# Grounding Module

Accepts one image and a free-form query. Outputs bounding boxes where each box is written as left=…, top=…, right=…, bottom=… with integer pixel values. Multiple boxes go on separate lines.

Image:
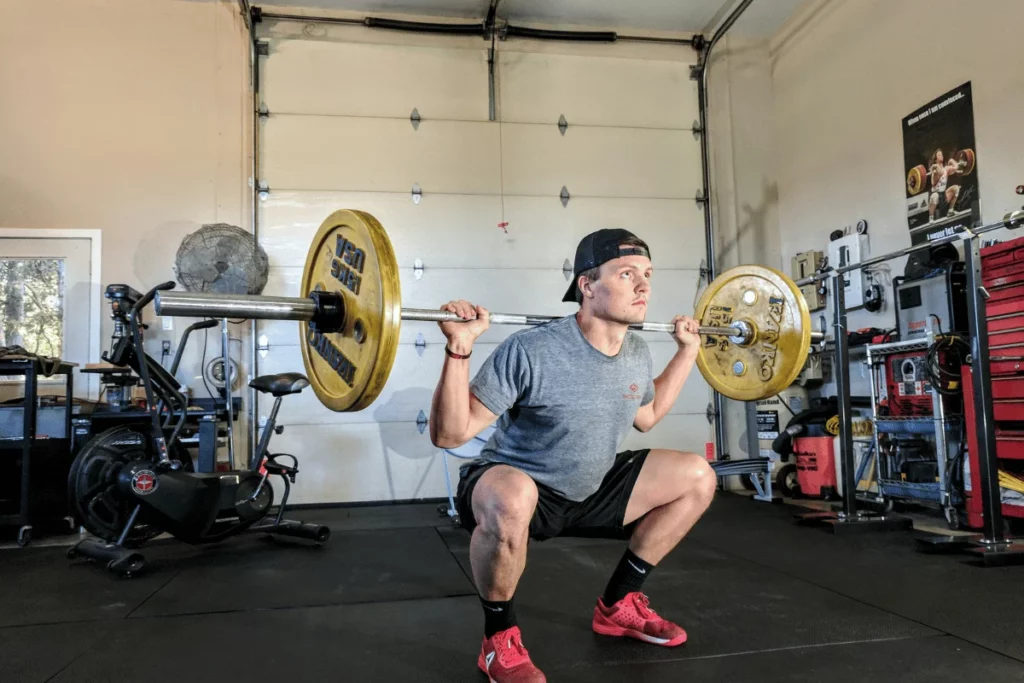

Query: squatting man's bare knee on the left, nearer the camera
left=473, top=466, right=538, bottom=543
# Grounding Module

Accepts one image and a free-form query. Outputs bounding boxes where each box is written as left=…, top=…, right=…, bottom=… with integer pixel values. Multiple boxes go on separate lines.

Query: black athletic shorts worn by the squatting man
left=455, top=449, right=650, bottom=541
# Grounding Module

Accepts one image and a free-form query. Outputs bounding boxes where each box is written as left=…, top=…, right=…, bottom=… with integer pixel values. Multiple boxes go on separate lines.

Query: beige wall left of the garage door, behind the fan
left=0, top=0, right=249, bottom=447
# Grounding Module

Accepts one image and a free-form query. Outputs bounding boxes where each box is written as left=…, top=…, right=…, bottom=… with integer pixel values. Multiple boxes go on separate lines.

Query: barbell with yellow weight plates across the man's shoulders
left=155, top=210, right=820, bottom=412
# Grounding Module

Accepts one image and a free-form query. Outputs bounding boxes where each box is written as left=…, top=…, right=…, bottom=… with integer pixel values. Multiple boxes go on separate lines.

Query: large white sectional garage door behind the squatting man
left=253, top=18, right=711, bottom=503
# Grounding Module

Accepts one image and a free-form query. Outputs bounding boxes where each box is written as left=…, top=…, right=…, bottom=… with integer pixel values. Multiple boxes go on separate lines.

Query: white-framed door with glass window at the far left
left=0, top=232, right=99, bottom=398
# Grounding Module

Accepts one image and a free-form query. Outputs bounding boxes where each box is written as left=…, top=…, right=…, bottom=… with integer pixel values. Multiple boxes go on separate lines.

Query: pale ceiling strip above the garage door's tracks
left=260, top=0, right=805, bottom=37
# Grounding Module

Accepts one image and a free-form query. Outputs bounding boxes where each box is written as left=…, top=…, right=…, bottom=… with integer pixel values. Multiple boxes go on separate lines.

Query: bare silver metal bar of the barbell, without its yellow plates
left=155, top=292, right=821, bottom=340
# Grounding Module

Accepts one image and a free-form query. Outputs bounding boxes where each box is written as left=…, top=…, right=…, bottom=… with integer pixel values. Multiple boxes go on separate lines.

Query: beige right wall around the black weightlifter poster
left=772, top=0, right=1024, bottom=337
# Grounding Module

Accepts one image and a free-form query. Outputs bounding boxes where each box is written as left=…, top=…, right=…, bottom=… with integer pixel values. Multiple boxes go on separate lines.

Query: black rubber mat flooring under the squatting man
left=0, top=494, right=1024, bottom=683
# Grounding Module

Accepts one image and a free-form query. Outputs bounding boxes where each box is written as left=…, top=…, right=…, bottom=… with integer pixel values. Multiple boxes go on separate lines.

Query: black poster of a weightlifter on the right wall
left=903, top=82, right=981, bottom=244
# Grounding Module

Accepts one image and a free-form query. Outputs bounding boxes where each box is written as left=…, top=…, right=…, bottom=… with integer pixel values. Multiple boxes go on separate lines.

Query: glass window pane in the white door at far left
left=0, top=258, right=65, bottom=357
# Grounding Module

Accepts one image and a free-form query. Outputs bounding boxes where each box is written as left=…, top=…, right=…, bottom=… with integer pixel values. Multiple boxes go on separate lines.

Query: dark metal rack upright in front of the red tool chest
left=964, top=237, right=1007, bottom=546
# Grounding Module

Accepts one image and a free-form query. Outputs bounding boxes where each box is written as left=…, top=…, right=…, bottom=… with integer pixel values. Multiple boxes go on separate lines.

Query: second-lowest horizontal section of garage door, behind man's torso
left=260, top=340, right=710, bottom=425
